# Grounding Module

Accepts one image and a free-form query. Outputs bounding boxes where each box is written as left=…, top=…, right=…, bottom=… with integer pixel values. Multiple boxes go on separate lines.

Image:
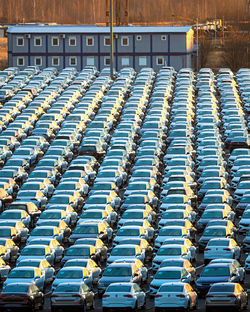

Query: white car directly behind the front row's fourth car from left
left=149, top=266, right=191, bottom=296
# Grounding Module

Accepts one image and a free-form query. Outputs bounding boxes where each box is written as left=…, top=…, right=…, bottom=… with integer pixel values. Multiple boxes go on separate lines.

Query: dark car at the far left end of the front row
left=0, top=281, right=44, bottom=311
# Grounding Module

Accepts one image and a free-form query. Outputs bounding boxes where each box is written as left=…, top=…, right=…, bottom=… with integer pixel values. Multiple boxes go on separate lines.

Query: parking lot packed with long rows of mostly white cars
left=0, top=66, right=250, bottom=311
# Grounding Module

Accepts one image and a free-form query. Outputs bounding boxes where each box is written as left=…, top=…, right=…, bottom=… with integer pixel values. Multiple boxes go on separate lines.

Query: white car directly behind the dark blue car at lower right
left=204, top=238, right=240, bottom=263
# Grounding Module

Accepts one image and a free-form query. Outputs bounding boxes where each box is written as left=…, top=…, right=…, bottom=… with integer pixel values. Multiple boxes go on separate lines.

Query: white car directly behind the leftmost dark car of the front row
left=3, top=267, right=45, bottom=291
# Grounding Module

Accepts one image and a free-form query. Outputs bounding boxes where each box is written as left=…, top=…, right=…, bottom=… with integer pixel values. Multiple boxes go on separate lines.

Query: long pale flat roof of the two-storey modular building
left=7, top=25, right=192, bottom=34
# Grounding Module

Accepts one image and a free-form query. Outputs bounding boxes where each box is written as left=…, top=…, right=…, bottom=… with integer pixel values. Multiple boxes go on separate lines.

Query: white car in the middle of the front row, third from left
left=102, top=283, right=146, bottom=312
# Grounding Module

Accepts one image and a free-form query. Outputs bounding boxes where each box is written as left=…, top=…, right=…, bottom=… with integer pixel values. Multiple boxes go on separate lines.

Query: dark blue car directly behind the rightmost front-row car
left=196, top=263, right=240, bottom=296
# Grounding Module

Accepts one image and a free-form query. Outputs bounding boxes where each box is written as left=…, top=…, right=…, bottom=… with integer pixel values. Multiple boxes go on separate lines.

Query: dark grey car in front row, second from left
left=50, top=281, right=94, bottom=312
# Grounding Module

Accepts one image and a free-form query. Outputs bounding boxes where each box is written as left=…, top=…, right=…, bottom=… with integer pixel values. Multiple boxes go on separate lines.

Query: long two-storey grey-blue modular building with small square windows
left=8, top=25, right=194, bottom=71
